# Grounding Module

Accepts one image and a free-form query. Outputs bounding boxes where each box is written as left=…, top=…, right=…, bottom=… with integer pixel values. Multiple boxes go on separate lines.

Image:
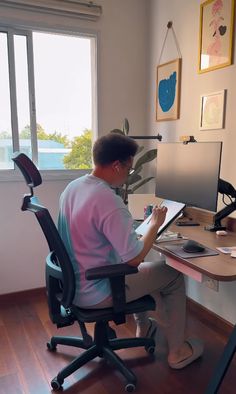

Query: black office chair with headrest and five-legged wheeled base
left=12, top=152, right=155, bottom=392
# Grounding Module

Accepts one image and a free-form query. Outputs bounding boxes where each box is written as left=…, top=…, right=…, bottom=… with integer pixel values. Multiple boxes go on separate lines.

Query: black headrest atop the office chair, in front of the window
left=12, top=152, right=42, bottom=188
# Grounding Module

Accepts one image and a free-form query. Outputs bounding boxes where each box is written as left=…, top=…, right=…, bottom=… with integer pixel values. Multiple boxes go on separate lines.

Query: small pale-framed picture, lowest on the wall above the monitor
left=200, top=90, right=226, bottom=130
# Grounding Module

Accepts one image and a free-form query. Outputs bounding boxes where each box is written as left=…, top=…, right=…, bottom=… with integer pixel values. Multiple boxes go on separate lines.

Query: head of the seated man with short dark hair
left=93, top=133, right=138, bottom=187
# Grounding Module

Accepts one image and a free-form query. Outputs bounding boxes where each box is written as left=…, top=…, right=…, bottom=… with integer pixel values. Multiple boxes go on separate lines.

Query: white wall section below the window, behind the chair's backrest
left=0, top=182, right=66, bottom=294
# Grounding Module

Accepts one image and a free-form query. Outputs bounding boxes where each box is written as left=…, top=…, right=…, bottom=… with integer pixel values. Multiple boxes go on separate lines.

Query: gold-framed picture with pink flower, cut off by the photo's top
left=198, top=0, right=234, bottom=73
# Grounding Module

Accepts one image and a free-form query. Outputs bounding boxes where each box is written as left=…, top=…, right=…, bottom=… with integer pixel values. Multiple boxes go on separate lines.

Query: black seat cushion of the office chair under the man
left=72, top=295, right=156, bottom=323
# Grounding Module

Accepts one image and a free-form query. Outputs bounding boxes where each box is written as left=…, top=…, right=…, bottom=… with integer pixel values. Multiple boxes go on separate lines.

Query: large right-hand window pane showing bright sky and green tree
left=33, top=32, right=92, bottom=169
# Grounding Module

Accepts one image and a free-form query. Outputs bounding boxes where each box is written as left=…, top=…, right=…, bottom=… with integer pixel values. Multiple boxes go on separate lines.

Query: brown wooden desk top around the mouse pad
left=153, top=222, right=236, bottom=281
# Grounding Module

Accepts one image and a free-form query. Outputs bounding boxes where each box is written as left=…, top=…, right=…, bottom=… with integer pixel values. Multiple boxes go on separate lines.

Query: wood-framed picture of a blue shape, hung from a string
left=156, top=59, right=181, bottom=121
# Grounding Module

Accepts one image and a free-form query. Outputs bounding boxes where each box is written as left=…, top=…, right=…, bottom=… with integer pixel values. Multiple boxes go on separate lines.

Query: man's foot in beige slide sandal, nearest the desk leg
left=168, top=338, right=204, bottom=369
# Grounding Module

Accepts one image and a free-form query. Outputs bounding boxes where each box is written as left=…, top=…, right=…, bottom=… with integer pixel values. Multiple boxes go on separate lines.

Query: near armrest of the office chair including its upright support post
left=85, top=263, right=138, bottom=324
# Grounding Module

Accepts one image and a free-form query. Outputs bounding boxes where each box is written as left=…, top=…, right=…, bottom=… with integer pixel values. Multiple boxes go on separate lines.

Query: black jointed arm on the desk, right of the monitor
left=206, top=179, right=236, bottom=231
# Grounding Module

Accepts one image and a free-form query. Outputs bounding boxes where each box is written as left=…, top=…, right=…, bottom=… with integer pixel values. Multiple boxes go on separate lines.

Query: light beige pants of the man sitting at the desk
left=93, top=255, right=186, bottom=351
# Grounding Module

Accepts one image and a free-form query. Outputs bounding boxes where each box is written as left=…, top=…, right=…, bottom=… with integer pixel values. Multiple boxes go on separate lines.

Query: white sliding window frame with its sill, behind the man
left=0, top=21, right=98, bottom=182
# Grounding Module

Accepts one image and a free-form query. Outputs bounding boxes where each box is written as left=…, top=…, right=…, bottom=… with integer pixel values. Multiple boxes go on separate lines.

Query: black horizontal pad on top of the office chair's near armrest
left=85, top=264, right=138, bottom=280
